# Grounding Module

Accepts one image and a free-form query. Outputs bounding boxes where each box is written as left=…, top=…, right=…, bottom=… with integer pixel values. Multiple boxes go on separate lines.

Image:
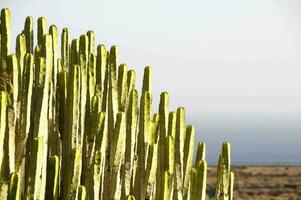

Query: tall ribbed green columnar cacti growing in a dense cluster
left=0, top=9, right=233, bottom=200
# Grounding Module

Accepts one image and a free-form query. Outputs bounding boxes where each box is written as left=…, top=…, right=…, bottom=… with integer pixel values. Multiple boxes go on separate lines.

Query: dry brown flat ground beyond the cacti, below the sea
left=207, top=166, right=301, bottom=200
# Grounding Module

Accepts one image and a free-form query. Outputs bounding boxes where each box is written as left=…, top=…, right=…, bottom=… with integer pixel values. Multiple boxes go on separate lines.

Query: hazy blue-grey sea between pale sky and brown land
left=186, top=113, right=301, bottom=165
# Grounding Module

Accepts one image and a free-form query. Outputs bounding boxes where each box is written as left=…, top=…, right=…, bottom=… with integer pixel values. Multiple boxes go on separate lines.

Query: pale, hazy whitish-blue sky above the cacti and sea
left=0, top=0, right=301, bottom=163
